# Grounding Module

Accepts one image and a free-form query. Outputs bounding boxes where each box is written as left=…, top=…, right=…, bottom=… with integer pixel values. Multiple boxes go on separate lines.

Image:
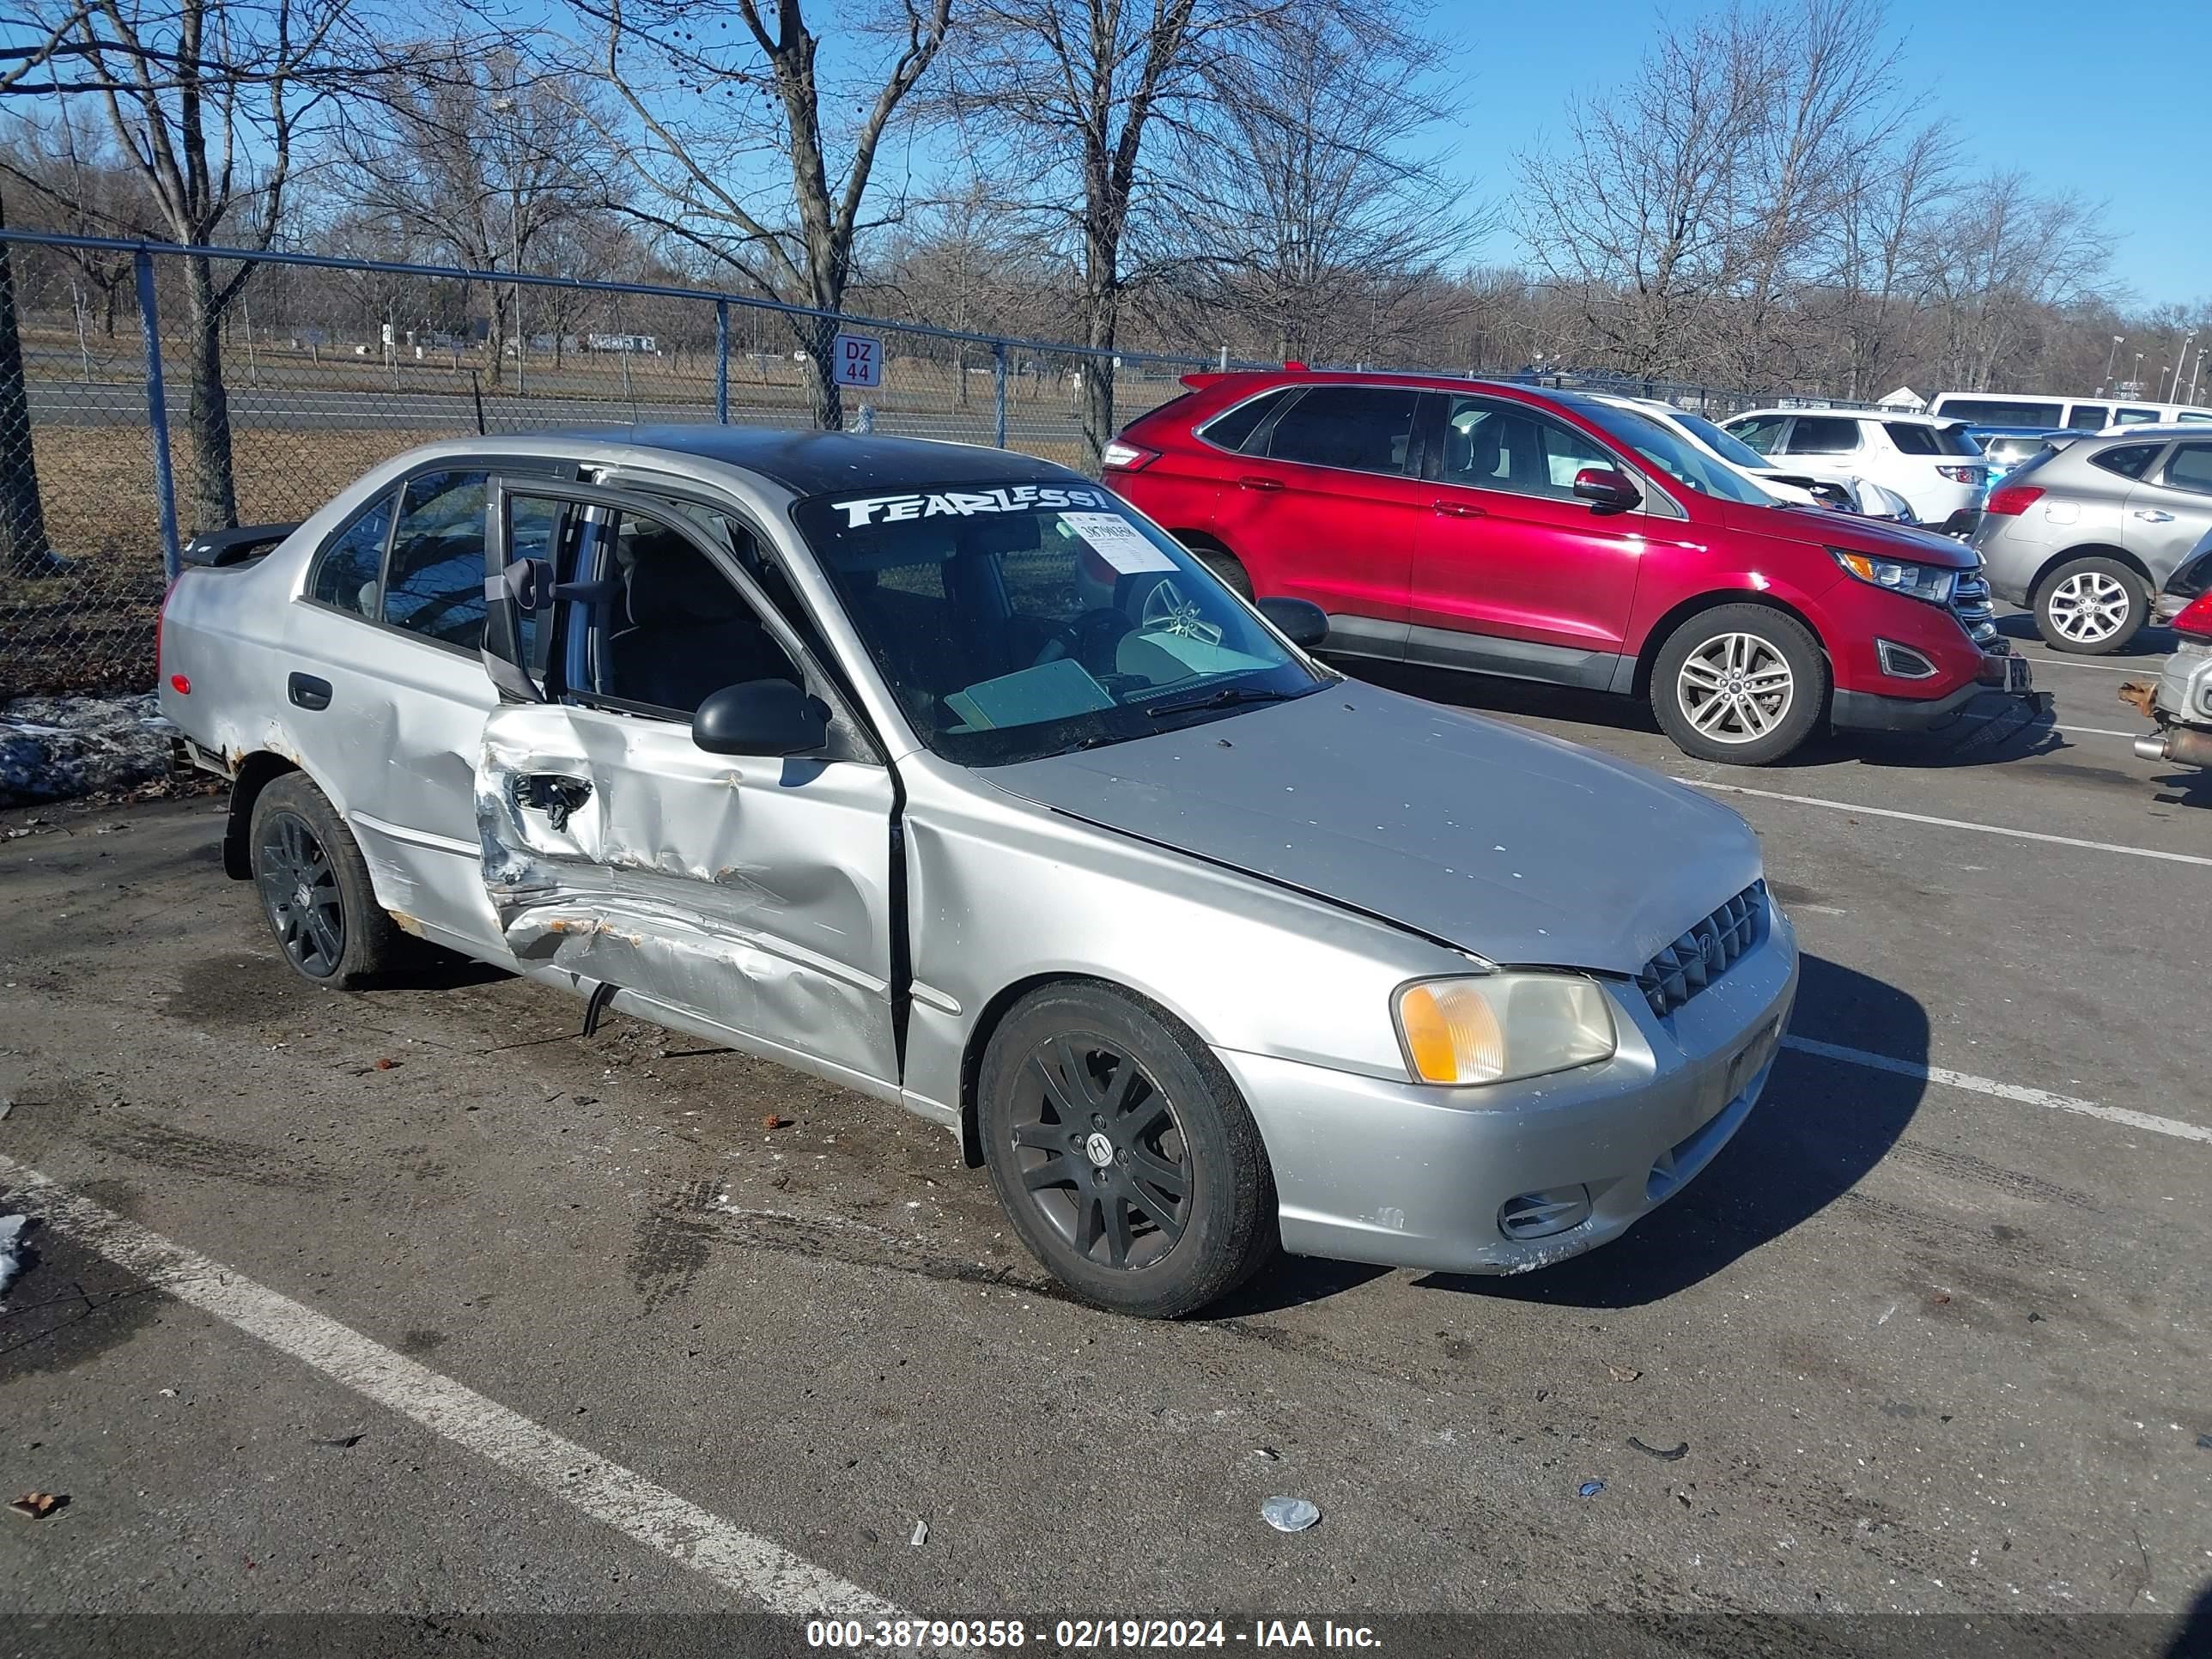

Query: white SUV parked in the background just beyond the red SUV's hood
left=1725, top=410, right=1989, bottom=526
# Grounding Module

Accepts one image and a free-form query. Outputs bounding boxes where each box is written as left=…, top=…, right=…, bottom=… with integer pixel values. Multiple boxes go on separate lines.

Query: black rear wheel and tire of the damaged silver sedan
left=246, top=772, right=410, bottom=991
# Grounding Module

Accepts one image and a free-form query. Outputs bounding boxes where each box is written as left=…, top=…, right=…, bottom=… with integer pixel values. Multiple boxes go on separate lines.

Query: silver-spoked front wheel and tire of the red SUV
left=1650, top=604, right=1829, bottom=765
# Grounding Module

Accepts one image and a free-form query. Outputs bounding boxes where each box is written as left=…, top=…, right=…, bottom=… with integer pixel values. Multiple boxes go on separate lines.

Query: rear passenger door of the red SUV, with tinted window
left=1214, top=385, right=1433, bottom=654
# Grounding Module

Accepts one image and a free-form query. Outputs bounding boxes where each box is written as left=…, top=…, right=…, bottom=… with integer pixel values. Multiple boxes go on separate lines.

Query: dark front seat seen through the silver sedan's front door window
left=602, top=531, right=796, bottom=714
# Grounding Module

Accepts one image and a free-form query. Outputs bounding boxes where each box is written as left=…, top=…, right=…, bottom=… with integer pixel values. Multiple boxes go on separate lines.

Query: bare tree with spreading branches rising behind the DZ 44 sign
left=571, top=0, right=951, bottom=429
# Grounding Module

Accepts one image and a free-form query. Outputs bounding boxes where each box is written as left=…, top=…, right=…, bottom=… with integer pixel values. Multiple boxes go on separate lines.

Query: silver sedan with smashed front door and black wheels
left=161, top=427, right=1798, bottom=1316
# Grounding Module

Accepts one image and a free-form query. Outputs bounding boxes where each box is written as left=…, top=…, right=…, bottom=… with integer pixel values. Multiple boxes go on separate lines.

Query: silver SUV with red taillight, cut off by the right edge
left=1973, top=425, right=2212, bottom=657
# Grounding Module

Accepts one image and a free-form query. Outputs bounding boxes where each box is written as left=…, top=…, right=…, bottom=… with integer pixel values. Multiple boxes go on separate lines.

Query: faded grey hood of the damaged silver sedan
left=982, top=684, right=1759, bottom=975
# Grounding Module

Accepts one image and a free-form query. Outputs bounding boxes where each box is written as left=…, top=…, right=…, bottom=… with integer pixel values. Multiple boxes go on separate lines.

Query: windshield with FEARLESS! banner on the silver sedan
left=792, top=484, right=1328, bottom=765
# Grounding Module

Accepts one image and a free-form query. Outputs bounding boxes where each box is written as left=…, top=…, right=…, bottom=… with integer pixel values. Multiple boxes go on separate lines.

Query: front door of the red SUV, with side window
left=1407, top=394, right=1646, bottom=686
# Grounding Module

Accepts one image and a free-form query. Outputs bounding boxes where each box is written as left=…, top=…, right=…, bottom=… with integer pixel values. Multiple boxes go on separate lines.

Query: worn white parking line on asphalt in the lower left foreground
left=0, top=1155, right=911, bottom=1624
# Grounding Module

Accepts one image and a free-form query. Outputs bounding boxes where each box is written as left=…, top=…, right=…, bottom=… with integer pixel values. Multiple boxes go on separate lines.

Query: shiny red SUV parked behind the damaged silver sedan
left=1106, top=369, right=2028, bottom=765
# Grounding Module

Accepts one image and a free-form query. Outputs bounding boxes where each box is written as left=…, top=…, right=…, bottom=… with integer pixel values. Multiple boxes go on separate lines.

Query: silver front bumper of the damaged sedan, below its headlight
left=1214, top=909, right=1798, bottom=1274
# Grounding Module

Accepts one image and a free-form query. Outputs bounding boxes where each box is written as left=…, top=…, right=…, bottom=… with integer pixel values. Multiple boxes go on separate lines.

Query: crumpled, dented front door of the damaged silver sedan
left=476, top=477, right=898, bottom=1097
